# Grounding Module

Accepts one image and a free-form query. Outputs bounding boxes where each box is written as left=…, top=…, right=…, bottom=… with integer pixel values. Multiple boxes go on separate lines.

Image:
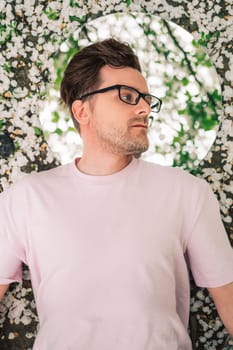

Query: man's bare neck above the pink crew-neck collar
left=76, top=153, right=133, bottom=176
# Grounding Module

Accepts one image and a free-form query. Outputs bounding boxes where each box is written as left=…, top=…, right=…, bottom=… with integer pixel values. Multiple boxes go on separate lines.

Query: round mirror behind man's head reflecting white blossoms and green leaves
left=40, top=13, right=221, bottom=173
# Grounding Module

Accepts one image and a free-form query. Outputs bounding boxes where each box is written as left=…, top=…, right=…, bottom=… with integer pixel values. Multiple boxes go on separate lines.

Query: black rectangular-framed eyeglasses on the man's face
left=77, top=84, right=162, bottom=113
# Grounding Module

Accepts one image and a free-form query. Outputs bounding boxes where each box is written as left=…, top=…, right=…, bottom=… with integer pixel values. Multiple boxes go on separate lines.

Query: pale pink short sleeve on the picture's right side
left=187, top=182, right=233, bottom=288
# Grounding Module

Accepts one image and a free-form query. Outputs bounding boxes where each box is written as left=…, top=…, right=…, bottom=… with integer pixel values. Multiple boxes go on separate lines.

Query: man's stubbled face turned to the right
left=83, top=66, right=151, bottom=155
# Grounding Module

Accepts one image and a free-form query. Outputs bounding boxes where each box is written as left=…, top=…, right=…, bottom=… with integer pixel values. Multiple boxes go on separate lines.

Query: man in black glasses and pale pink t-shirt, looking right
left=0, top=39, right=233, bottom=350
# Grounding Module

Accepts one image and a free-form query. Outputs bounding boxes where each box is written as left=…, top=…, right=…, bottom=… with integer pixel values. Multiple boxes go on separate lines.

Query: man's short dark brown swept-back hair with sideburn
left=60, top=38, right=141, bottom=131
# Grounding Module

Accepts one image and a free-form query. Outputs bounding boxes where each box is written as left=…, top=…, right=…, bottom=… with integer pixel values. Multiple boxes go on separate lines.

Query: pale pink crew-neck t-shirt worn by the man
left=0, top=159, right=233, bottom=350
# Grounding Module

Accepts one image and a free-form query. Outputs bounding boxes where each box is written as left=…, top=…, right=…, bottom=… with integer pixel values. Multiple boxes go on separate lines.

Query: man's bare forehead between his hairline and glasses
left=99, top=65, right=148, bottom=92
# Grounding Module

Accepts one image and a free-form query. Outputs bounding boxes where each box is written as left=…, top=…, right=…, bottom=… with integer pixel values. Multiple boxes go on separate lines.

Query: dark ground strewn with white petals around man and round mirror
left=0, top=0, right=233, bottom=350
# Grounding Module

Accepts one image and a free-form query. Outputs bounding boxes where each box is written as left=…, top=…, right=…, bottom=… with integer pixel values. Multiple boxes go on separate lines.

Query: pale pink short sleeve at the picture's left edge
left=0, top=186, right=25, bottom=284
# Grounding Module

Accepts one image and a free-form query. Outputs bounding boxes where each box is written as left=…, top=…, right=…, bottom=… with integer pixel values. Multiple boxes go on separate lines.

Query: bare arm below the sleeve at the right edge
left=208, top=282, right=233, bottom=337
